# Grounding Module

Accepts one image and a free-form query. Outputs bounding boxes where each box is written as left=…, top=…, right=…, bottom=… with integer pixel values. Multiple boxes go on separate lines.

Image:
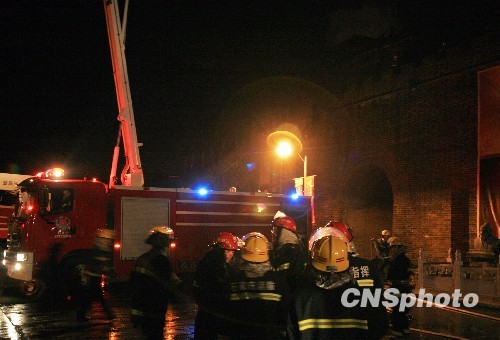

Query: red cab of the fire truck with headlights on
left=3, top=169, right=107, bottom=295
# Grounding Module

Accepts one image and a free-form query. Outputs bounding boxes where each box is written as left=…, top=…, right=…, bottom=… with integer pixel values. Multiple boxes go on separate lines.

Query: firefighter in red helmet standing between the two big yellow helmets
left=271, top=212, right=307, bottom=291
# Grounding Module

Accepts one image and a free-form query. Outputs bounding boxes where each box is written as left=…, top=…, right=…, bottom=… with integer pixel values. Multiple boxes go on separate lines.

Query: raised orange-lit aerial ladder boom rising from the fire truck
left=103, top=0, right=144, bottom=188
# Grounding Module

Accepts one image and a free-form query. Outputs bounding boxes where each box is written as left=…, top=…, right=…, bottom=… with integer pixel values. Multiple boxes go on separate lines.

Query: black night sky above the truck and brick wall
left=0, top=0, right=498, bottom=185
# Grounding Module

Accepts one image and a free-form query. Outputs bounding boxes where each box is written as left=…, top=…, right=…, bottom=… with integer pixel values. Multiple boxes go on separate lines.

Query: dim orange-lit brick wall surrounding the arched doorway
left=309, top=36, right=500, bottom=261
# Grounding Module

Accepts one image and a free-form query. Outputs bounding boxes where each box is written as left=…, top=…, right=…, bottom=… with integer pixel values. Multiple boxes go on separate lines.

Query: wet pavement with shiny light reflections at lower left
left=0, top=289, right=197, bottom=340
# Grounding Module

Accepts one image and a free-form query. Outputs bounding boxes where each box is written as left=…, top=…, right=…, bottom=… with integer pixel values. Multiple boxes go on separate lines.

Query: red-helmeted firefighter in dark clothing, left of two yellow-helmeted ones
left=193, top=232, right=238, bottom=339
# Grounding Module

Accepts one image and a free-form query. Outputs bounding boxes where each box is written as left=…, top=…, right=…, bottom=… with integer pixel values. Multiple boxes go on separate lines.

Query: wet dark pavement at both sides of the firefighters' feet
left=0, top=266, right=500, bottom=340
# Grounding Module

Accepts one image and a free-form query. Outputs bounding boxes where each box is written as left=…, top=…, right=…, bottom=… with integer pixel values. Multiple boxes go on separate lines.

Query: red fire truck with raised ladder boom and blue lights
left=3, top=0, right=313, bottom=299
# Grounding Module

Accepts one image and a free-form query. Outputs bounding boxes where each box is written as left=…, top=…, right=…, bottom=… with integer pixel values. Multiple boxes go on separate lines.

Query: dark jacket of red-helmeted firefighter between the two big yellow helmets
left=272, top=239, right=307, bottom=291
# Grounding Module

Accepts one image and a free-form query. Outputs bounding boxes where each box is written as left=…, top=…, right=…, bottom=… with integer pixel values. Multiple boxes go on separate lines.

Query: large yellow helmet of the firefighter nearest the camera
left=311, top=236, right=349, bottom=273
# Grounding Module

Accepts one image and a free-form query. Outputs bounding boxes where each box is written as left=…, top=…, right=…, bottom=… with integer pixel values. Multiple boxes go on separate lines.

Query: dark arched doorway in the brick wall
left=343, top=167, right=393, bottom=258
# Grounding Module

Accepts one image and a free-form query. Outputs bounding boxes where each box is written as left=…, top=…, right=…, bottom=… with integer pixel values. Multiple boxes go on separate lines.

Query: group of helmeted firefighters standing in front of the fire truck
left=80, top=212, right=413, bottom=339
